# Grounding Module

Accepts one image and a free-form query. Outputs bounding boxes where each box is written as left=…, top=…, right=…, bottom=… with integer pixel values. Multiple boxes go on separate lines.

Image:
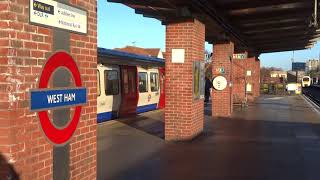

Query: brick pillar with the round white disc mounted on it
left=211, top=42, right=234, bottom=117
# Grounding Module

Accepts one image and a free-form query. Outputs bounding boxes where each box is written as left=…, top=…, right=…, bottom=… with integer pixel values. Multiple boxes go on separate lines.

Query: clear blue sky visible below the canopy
left=98, top=0, right=320, bottom=70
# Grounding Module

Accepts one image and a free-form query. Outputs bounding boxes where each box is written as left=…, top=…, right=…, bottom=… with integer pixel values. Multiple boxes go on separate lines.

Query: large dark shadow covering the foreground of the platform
left=100, top=118, right=320, bottom=180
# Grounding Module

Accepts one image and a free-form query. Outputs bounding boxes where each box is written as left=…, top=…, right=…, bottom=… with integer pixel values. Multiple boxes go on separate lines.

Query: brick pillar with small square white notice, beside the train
left=165, top=20, right=205, bottom=140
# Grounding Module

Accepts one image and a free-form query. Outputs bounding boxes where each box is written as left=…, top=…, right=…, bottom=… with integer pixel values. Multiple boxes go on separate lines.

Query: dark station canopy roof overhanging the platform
left=108, top=0, right=320, bottom=54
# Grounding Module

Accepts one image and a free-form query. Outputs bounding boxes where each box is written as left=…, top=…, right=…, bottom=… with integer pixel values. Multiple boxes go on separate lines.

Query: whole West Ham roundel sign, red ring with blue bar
left=30, top=52, right=87, bottom=145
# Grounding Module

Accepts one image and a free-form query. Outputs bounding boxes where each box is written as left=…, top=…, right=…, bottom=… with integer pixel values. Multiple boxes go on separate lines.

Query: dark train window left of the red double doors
left=104, top=70, right=119, bottom=96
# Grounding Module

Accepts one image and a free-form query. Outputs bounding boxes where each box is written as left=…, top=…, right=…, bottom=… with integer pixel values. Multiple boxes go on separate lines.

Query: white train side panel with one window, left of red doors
left=97, top=65, right=121, bottom=123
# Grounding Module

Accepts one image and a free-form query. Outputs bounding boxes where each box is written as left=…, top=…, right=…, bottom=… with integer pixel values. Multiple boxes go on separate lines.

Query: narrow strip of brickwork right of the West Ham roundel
left=70, top=0, right=98, bottom=179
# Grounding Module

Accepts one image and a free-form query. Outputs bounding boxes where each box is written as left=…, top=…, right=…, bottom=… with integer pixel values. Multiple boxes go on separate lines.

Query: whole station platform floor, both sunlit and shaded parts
left=97, top=96, right=320, bottom=180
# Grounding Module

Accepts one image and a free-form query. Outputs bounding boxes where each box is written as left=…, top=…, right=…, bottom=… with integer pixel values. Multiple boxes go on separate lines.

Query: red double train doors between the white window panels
left=120, top=66, right=139, bottom=116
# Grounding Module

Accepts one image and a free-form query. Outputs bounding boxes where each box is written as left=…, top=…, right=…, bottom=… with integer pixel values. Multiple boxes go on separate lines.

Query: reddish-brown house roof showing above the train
left=115, top=46, right=161, bottom=57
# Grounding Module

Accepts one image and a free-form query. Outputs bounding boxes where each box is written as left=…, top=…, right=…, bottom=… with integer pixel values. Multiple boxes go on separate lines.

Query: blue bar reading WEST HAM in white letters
left=30, top=88, right=87, bottom=111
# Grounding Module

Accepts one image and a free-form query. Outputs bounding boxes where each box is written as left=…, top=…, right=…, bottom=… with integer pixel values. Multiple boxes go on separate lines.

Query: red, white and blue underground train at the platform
left=97, top=48, right=165, bottom=123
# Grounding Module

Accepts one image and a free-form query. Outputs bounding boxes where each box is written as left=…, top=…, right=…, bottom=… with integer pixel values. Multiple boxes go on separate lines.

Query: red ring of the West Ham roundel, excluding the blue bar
left=38, top=52, right=82, bottom=145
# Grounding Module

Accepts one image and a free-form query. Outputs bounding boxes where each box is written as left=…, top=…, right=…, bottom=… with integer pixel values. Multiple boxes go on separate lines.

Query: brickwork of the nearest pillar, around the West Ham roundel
left=0, top=0, right=97, bottom=179
